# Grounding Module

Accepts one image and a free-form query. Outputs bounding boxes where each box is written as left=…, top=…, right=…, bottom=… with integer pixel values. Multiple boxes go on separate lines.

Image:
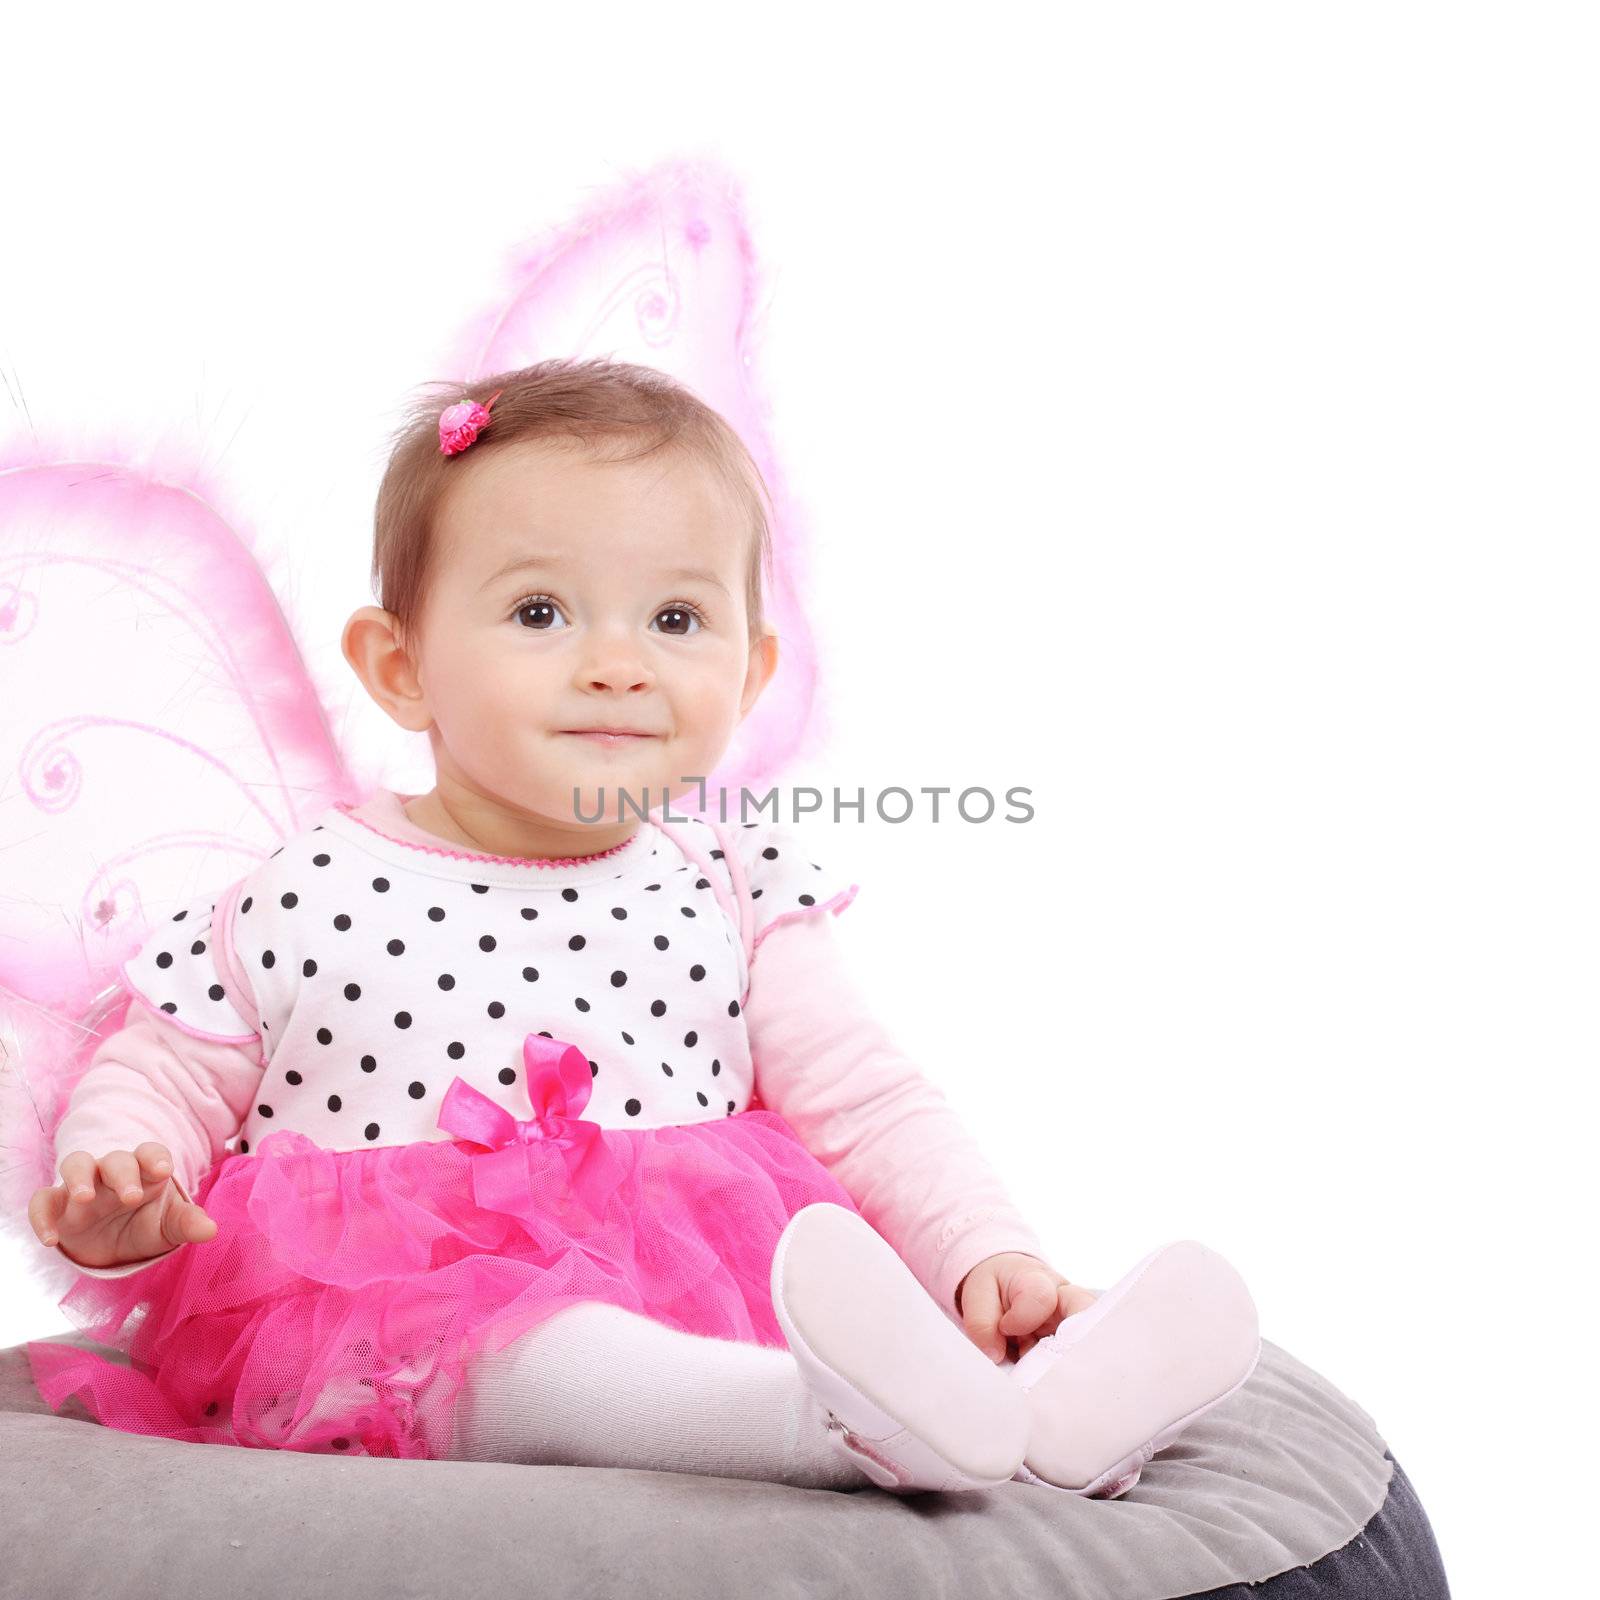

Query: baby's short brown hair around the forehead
left=373, top=357, right=771, bottom=642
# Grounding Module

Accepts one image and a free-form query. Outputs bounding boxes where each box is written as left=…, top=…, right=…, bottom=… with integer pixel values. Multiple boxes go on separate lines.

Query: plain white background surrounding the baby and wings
left=0, top=3, right=1600, bottom=1600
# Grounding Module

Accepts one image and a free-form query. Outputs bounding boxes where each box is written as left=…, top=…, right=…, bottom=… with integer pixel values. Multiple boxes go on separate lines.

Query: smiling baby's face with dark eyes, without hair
left=406, top=443, right=776, bottom=826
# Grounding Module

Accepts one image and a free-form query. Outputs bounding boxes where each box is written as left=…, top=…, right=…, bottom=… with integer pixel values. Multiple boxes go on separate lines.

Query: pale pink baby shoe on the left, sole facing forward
left=771, top=1200, right=1029, bottom=1493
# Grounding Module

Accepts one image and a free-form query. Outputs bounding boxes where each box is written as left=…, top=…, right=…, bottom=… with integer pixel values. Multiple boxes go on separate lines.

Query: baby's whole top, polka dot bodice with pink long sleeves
left=56, top=789, right=1043, bottom=1320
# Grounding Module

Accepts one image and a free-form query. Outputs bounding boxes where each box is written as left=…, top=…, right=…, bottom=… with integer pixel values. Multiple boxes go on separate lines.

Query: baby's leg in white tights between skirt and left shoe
left=448, top=1301, right=867, bottom=1490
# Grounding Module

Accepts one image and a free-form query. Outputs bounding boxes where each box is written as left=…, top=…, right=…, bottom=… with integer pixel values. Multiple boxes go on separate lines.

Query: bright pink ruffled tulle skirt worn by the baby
left=27, top=1107, right=856, bottom=1459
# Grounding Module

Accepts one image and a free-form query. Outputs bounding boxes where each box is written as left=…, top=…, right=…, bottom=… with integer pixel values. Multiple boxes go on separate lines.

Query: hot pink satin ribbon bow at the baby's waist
left=438, top=1034, right=624, bottom=1218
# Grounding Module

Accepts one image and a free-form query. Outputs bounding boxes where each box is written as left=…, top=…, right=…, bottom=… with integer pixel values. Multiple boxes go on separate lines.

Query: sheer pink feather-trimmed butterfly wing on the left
left=0, top=461, right=355, bottom=1260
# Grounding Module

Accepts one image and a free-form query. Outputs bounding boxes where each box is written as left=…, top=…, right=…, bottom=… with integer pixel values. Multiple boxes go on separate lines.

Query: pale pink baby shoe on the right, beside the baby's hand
left=1000, top=1238, right=1261, bottom=1499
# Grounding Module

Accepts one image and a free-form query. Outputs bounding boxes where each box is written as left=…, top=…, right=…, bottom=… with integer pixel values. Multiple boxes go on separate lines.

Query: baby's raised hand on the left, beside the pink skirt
left=27, top=1139, right=216, bottom=1267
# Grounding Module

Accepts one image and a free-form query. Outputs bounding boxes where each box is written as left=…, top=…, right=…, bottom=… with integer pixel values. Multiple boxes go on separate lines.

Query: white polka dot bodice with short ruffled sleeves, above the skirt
left=123, top=790, right=858, bottom=1154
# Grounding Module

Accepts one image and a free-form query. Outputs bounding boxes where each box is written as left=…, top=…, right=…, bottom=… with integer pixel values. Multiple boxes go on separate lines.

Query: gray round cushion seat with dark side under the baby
left=0, top=1334, right=1448, bottom=1600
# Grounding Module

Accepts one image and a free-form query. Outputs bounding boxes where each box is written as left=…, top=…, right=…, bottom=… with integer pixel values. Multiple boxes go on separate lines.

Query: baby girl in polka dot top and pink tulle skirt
left=18, top=360, right=1259, bottom=1496
